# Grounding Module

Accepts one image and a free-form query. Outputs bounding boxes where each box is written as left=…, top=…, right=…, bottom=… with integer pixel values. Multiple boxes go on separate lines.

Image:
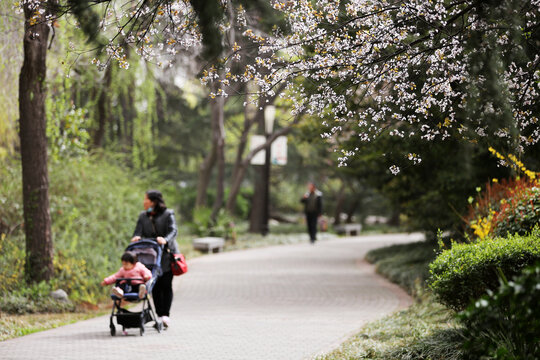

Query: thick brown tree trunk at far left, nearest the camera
left=19, top=2, right=54, bottom=282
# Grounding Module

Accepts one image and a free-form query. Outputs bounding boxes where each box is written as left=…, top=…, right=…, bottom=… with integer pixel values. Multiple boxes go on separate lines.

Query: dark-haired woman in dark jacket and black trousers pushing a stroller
left=131, top=190, right=179, bottom=327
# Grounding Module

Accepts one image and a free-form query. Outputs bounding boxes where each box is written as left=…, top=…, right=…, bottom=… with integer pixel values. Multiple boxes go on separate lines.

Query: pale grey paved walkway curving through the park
left=0, top=235, right=420, bottom=360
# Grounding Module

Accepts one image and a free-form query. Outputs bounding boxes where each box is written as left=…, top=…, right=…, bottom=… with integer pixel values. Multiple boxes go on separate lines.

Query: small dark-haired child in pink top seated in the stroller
left=101, top=251, right=152, bottom=299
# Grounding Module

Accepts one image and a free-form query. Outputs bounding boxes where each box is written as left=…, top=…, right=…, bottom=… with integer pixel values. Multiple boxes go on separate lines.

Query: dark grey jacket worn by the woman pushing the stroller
left=133, top=209, right=180, bottom=272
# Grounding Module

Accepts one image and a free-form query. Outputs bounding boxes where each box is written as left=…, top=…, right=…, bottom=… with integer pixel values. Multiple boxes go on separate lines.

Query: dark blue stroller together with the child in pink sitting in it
left=102, top=239, right=163, bottom=336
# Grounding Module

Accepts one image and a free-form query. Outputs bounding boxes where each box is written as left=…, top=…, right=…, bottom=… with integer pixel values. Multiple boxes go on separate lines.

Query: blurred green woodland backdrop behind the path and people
left=0, top=1, right=539, bottom=310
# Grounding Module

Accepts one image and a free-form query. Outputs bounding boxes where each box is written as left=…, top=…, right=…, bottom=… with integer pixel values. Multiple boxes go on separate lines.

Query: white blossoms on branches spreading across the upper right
left=207, top=0, right=540, bottom=173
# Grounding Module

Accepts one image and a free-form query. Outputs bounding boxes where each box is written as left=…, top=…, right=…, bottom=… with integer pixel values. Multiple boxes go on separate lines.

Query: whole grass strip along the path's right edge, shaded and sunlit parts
left=317, top=241, right=464, bottom=360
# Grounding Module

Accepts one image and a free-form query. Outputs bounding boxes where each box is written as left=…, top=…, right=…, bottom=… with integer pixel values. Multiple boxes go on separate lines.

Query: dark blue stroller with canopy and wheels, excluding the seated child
left=109, top=239, right=163, bottom=336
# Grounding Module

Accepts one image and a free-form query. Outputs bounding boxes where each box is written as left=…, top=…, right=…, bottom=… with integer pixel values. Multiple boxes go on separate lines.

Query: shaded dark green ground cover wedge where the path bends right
left=366, top=241, right=437, bottom=294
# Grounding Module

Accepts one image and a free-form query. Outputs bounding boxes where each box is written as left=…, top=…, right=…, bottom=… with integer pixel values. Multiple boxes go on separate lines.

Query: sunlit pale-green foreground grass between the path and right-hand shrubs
left=316, top=295, right=462, bottom=360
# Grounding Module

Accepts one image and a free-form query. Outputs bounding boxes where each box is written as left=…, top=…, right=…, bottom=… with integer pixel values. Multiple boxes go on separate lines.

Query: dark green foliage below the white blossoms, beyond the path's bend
left=338, top=128, right=508, bottom=234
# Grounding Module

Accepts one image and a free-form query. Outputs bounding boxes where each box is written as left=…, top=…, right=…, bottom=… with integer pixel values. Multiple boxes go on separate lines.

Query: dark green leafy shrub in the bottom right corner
left=459, top=264, right=540, bottom=360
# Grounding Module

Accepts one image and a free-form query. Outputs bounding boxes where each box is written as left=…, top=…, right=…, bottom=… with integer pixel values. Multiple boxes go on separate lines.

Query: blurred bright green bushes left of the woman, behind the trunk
left=0, top=155, right=158, bottom=311
